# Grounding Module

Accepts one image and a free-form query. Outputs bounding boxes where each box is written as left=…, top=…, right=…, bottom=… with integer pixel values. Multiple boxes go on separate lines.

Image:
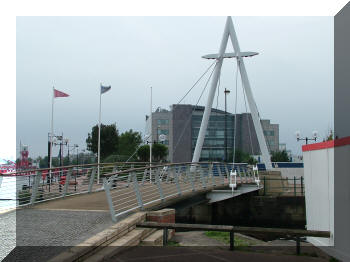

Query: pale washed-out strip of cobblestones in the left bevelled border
left=0, top=212, right=16, bottom=261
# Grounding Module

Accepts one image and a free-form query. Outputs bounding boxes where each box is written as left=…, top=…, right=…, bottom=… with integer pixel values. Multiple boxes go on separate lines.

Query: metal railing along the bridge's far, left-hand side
left=0, top=162, right=149, bottom=210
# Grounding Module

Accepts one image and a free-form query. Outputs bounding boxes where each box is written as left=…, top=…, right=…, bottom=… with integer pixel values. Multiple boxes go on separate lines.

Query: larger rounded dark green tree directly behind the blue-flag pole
left=86, top=124, right=119, bottom=158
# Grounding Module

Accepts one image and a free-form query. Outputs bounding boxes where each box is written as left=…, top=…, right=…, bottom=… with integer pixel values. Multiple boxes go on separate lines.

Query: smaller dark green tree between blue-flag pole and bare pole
left=118, top=129, right=142, bottom=158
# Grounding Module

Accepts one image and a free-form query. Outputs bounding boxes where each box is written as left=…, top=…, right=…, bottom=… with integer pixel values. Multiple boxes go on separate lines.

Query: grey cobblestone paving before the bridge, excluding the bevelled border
left=17, top=208, right=112, bottom=246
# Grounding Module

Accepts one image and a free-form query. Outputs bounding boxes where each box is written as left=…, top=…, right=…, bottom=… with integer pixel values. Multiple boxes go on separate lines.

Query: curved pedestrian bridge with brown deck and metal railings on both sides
left=0, top=162, right=260, bottom=222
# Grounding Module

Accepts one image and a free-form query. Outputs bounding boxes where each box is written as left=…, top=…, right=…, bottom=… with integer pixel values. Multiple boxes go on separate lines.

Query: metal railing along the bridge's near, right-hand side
left=103, top=162, right=256, bottom=221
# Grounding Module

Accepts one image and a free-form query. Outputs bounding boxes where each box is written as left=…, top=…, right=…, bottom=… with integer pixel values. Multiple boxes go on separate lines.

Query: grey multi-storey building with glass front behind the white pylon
left=146, top=104, right=279, bottom=163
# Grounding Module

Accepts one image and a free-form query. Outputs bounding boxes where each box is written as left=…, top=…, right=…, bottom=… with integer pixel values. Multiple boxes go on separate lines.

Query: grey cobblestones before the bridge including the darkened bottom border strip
left=4, top=208, right=113, bottom=261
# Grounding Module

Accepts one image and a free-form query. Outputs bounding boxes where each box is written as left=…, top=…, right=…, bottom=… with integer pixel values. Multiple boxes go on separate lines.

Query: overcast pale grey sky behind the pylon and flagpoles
left=16, top=17, right=334, bottom=160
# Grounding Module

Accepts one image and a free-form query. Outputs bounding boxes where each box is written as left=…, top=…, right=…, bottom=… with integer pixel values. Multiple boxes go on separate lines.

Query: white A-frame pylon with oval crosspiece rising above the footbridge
left=192, top=16, right=272, bottom=170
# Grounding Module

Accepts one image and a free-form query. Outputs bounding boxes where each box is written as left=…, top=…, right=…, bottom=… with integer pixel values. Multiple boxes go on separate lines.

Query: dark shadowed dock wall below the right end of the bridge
left=172, top=192, right=306, bottom=229
